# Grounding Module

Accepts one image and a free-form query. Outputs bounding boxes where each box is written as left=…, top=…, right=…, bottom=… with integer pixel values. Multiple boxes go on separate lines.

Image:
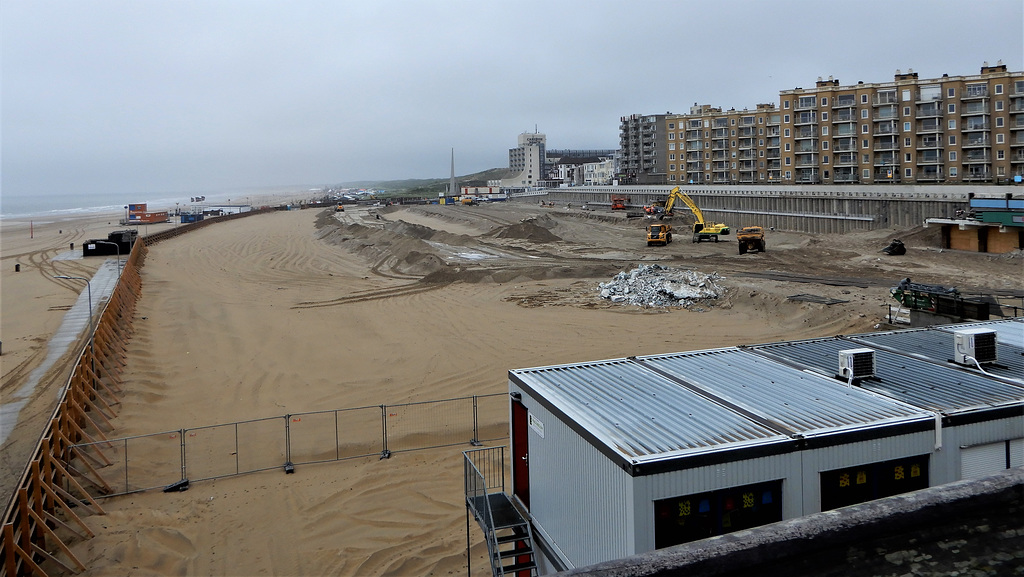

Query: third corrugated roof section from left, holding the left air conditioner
left=751, top=337, right=1024, bottom=414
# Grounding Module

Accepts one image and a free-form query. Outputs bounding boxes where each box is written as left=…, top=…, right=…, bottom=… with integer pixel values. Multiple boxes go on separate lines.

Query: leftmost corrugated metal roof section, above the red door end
left=510, top=359, right=790, bottom=462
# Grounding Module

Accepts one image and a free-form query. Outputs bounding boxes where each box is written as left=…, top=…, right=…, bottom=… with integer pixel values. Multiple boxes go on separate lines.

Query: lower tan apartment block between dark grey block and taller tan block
left=665, top=104, right=778, bottom=184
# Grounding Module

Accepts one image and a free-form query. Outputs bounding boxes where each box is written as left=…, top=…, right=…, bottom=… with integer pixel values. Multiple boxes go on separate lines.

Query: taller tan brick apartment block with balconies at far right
left=779, top=63, right=1024, bottom=184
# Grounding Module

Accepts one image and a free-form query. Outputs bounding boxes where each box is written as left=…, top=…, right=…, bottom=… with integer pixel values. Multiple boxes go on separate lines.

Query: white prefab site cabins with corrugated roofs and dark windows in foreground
left=509, top=323, right=1024, bottom=574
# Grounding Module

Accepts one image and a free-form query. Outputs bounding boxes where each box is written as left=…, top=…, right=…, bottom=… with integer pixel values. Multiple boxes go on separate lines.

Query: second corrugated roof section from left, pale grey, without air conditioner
left=642, top=348, right=931, bottom=437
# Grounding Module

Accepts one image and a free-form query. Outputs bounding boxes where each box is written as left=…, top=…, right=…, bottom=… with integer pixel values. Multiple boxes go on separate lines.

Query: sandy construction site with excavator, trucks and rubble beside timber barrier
left=4, top=189, right=1024, bottom=575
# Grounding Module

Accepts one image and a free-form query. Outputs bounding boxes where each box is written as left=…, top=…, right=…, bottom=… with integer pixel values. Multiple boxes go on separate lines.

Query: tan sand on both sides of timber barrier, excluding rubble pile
left=0, top=203, right=1022, bottom=575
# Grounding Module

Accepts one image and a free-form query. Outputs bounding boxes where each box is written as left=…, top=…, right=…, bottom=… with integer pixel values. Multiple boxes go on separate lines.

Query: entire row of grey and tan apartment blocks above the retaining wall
left=643, top=61, right=1024, bottom=184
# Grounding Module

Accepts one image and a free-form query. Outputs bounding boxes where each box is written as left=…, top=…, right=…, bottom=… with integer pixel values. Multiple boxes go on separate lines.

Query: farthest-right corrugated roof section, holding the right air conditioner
left=848, top=323, right=1024, bottom=383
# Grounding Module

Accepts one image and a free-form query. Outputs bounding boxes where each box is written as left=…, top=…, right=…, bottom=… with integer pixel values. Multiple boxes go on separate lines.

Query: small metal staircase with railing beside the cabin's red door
left=463, top=447, right=538, bottom=577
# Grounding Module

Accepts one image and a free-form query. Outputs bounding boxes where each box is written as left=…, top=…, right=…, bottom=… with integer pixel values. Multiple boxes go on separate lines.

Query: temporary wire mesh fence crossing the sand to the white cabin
left=72, top=394, right=508, bottom=497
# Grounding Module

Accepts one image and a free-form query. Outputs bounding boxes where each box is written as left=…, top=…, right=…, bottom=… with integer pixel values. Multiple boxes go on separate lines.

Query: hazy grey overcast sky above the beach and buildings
left=0, top=0, right=1024, bottom=195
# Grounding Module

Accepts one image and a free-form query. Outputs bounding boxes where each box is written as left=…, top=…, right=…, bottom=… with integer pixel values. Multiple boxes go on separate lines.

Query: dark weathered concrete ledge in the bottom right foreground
left=559, top=467, right=1024, bottom=577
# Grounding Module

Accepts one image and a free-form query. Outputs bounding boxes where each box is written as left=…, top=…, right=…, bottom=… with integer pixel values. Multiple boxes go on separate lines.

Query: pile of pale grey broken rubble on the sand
left=598, top=264, right=725, bottom=307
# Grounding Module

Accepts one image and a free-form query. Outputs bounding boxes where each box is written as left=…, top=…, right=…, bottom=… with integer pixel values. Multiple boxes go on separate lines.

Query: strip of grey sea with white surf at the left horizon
left=0, top=186, right=317, bottom=221
